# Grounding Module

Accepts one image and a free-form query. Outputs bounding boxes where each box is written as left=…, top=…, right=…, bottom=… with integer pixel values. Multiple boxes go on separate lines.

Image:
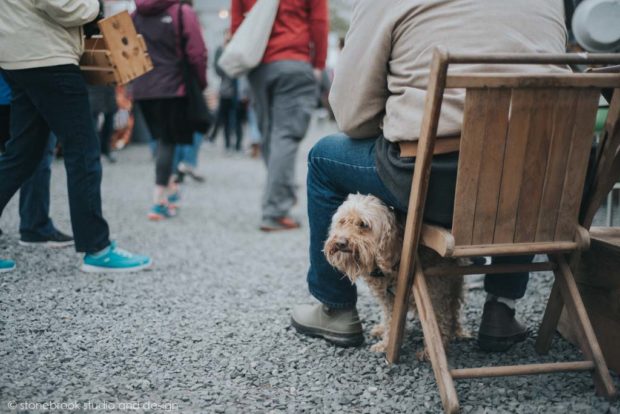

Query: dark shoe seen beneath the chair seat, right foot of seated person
left=478, top=300, right=528, bottom=352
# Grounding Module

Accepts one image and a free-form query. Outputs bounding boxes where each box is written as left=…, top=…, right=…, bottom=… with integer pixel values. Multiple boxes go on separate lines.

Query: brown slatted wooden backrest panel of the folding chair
left=448, top=84, right=600, bottom=246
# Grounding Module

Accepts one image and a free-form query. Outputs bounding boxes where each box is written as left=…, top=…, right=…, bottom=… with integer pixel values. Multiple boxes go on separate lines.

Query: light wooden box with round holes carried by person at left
left=80, top=11, right=153, bottom=85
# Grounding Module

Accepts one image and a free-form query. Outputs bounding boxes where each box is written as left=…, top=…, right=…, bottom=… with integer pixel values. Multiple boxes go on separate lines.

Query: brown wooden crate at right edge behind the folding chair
left=558, top=227, right=620, bottom=373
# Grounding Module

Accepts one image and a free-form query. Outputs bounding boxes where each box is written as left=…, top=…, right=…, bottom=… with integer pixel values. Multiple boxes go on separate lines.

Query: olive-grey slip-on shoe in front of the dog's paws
left=291, top=303, right=364, bottom=347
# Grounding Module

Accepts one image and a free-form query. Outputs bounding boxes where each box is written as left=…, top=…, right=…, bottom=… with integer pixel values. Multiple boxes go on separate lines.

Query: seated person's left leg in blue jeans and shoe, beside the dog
left=291, top=135, right=404, bottom=346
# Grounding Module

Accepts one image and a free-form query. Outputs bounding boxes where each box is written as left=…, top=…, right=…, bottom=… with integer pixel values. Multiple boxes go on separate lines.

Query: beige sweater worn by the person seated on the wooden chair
left=329, top=0, right=566, bottom=142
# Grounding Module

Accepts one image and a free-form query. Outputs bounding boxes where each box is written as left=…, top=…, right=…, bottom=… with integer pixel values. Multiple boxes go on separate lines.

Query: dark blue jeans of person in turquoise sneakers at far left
left=0, top=65, right=110, bottom=253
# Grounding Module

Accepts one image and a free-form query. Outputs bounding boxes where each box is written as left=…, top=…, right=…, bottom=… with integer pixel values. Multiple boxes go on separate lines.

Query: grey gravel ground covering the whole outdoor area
left=0, top=118, right=620, bottom=414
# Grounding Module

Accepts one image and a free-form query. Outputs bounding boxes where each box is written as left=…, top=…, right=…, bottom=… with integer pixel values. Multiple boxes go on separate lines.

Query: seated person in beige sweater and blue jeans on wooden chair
left=292, top=0, right=566, bottom=351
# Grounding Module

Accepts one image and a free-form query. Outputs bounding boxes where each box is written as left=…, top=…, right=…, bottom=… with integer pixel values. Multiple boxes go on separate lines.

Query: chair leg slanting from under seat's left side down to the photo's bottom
left=413, top=260, right=459, bottom=413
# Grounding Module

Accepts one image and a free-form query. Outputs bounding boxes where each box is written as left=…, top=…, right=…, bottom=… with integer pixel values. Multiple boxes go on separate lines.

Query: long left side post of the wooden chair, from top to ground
left=387, top=48, right=448, bottom=363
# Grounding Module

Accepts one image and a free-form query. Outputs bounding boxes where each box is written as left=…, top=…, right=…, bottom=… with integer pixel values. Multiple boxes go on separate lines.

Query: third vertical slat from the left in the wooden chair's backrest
left=493, top=90, right=534, bottom=243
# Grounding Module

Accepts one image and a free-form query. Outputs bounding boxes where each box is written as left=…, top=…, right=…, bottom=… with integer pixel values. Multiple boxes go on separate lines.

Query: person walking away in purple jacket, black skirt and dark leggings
left=133, top=0, right=207, bottom=221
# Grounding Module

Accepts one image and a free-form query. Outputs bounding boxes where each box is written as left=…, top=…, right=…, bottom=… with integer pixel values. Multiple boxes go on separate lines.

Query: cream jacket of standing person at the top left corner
left=0, top=0, right=99, bottom=70
